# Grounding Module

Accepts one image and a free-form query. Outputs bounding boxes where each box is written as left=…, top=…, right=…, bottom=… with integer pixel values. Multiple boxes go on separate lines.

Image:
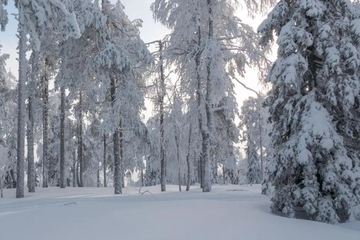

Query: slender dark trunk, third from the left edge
left=42, top=59, right=50, bottom=188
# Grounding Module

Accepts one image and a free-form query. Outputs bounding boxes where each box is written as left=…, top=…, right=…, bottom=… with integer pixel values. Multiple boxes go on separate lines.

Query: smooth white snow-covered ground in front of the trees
left=0, top=185, right=360, bottom=240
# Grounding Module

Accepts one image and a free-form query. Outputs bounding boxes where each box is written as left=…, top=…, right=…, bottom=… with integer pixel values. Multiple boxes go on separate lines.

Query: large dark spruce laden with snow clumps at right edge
left=259, top=0, right=360, bottom=223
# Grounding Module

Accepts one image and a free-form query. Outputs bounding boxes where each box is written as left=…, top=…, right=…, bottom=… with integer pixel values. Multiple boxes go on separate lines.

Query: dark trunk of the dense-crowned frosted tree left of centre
left=111, top=77, right=122, bottom=194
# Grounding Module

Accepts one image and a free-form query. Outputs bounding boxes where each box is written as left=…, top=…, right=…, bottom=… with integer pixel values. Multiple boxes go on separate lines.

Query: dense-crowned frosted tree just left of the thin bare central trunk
left=94, top=1, right=151, bottom=194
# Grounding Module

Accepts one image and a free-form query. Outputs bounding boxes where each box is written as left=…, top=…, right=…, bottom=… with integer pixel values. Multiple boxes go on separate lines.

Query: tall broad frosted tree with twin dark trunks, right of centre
left=152, top=0, right=261, bottom=192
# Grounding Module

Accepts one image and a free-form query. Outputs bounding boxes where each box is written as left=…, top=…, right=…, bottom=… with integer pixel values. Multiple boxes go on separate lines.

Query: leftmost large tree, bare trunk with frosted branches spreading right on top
left=15, top=0, right=80, bottom=198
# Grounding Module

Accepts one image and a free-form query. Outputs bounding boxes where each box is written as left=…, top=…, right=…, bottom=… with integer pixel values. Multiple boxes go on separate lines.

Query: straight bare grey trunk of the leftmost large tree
left=16, top=3, right=27, bottom=198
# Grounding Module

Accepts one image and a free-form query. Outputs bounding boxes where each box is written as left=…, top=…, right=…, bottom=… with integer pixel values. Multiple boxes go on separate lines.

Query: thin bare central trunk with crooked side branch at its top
left=159, top=40, right=166, bottom=192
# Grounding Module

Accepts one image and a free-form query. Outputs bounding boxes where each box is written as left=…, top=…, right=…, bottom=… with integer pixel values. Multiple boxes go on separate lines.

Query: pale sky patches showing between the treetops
left=0, top=0, right=270, bottom=108
